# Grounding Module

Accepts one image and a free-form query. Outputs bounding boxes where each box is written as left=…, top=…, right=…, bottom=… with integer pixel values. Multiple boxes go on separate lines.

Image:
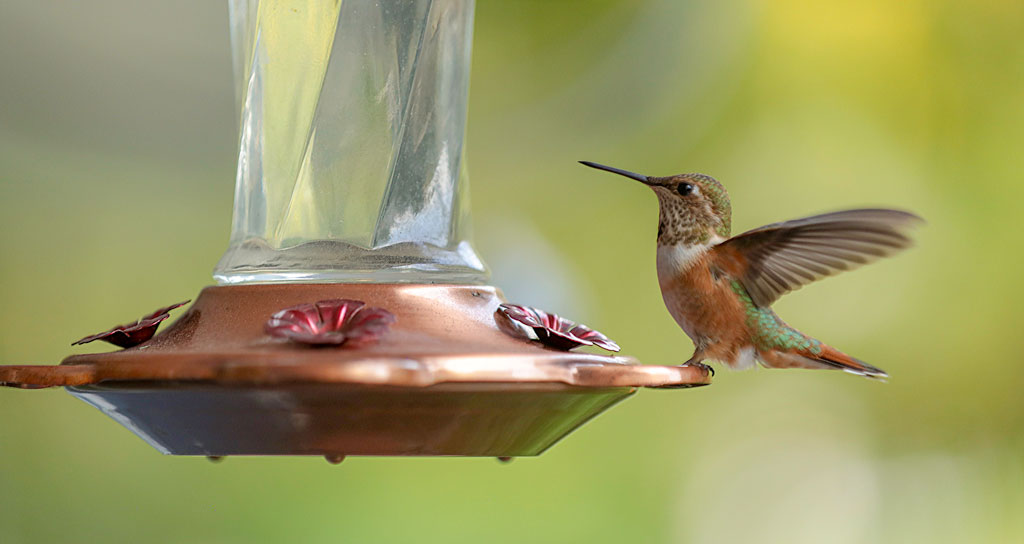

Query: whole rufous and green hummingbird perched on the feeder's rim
left=580, top=161, right=922, bottom=378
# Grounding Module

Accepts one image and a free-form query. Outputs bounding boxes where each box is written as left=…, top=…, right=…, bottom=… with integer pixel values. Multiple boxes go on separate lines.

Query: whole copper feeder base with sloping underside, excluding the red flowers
left=0, top=284, right=711, bottom=461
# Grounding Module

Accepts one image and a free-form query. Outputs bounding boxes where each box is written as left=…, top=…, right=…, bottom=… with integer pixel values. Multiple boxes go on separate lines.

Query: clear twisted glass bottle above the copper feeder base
left=214, top=0, right=487, bottom=284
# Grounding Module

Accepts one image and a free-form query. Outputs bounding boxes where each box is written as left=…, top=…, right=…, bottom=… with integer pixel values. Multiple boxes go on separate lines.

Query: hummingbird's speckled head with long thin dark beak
left=580, top=161, right=732, bottom=244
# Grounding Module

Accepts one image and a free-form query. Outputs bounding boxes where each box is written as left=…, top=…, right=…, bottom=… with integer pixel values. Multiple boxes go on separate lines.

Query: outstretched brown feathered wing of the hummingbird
left=712, top=209, right=922, bottom=307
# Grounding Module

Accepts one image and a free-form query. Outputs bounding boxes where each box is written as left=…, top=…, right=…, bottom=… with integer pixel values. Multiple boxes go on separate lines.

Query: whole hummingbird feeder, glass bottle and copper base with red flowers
left=0, top=0, right=711, bottom=462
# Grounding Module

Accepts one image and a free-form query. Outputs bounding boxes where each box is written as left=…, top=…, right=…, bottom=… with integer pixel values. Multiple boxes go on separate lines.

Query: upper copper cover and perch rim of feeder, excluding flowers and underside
left=0, top=284, right=711, bottom=388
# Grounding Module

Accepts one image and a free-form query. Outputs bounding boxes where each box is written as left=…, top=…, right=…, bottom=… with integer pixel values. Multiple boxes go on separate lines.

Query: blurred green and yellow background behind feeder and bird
left=0, top=0, right=1024, bottom=544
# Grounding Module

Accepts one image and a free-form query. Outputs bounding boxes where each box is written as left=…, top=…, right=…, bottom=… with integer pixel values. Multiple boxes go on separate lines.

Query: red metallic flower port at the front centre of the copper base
left=264, top=299, right=395, bottom=345
